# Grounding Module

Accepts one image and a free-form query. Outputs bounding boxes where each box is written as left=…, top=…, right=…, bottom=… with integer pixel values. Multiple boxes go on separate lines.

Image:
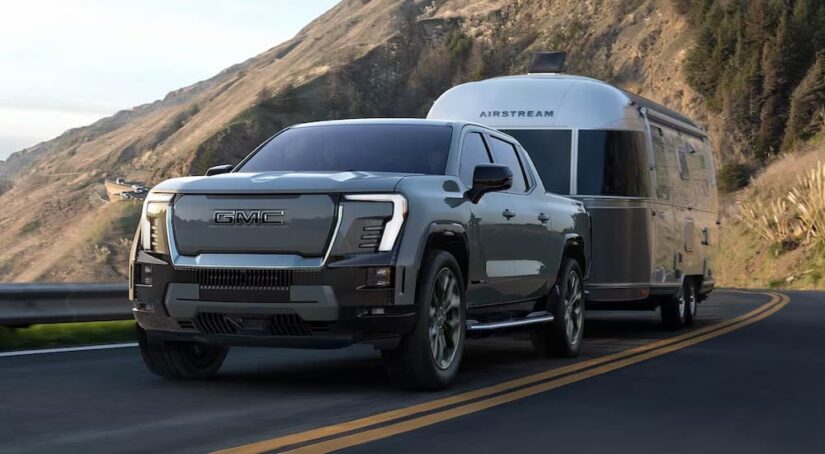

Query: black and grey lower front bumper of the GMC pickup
left=132, top=252, right=416, bottom=348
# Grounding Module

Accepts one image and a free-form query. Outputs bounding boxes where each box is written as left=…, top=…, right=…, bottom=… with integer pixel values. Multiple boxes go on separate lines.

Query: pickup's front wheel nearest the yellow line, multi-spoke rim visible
left=381, top=250, right=467, bottom=390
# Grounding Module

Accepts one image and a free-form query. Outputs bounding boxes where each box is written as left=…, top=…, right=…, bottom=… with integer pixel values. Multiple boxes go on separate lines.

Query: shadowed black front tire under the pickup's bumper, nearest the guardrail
left=137, top=326, right=229, bottom=380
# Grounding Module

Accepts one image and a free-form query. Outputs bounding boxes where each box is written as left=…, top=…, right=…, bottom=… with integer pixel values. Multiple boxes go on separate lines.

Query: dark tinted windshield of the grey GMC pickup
left=240, top=124, right=452, bottom=175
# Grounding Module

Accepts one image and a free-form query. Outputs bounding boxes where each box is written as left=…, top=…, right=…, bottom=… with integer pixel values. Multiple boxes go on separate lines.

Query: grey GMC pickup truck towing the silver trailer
left=130, top=119, right=590, bottom=389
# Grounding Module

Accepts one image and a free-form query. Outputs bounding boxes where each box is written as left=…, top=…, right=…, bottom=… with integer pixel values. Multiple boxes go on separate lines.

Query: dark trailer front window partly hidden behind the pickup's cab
left=503, top=129, right=572, bottom=194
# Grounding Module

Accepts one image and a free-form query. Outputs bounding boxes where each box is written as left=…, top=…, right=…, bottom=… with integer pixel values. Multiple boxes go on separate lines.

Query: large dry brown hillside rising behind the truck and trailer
left=0, top=0, right=820, bottom=281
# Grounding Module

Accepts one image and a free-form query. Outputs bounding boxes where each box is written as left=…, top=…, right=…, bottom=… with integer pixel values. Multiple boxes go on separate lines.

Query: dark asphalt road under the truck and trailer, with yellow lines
left=0, top=291, right=825, bottom=453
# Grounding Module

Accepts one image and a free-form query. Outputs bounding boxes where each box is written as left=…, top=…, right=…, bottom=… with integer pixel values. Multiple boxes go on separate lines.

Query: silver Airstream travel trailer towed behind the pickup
left=428, top=53, right=719, bottom=328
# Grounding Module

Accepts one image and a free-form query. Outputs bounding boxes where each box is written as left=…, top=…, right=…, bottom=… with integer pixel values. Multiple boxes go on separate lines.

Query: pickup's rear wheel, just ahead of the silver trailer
left=530, top=257, right=585, bottom=358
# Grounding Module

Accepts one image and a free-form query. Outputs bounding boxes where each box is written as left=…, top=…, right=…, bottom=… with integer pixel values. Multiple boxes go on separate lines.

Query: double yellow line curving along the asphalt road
left=219, top=293, right=790, bottom=454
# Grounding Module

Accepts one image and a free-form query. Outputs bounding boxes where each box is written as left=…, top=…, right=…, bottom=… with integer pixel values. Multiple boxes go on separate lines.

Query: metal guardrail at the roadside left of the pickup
left=0, top=283, right=132, bottom=326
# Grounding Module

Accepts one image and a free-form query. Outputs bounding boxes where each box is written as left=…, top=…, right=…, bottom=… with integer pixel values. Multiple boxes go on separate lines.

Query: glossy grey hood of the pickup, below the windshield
left=152, top=172, right=409, bottom=194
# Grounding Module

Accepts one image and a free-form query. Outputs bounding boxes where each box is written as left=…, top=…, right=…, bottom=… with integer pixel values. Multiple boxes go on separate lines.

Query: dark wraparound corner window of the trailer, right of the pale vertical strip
left=577, top=130, right=650, bottom=197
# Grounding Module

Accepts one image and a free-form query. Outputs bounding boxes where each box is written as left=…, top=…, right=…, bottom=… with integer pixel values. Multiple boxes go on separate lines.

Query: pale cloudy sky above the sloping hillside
left=0, top=0, right=337, bottom=160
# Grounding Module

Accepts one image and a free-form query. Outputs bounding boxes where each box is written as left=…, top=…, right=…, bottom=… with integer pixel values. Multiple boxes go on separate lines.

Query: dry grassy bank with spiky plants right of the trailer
left=715, top=135, right=825, bottom=289
